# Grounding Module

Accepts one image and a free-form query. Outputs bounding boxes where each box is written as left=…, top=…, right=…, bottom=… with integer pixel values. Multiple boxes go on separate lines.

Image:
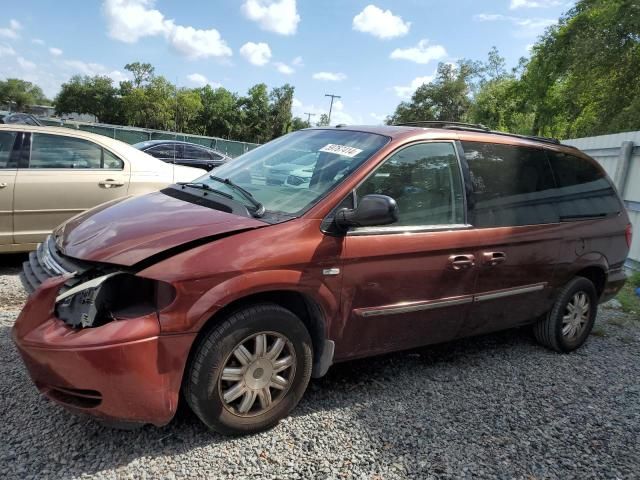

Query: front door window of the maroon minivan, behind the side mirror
left=356, top=143, right=464, bottom=226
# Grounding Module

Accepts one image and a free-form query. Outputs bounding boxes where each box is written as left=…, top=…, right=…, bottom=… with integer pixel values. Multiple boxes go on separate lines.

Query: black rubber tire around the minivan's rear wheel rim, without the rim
left=533, top=277, right=598, bottom=352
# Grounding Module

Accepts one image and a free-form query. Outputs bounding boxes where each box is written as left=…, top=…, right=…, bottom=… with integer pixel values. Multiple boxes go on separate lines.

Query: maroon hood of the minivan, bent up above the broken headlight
left=54, top=192, right=267, bottom=266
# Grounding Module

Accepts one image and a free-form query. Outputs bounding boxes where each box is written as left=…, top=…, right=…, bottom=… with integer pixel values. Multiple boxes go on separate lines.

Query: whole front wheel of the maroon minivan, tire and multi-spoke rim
left=185, top=304, right=313, bottom=434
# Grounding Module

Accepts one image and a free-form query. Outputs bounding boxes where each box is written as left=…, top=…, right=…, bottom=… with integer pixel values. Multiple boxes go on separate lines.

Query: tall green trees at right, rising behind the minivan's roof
left=386, top=0, right=640, bottom=138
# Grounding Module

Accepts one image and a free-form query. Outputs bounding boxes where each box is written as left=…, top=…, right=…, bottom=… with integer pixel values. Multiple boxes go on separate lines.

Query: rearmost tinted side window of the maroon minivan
left=548, top=151, right=622, bottom=221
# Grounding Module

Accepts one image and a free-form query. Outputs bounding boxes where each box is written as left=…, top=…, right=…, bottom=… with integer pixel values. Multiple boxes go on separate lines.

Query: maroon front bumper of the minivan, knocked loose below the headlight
left=12, top=276, right=196, bottom=426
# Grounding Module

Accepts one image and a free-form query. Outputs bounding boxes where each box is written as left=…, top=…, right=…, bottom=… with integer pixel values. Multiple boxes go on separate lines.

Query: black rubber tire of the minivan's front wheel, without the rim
left=184, top=303, right=313, bottom=435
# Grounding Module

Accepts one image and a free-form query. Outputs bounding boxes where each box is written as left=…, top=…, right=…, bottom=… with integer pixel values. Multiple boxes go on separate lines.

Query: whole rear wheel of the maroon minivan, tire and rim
left=533, top=277, right=598, bottom=352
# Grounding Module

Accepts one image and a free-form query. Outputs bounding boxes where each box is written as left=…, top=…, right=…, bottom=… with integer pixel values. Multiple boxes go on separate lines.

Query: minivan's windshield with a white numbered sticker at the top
left=194, top=129, right=389, bottom=216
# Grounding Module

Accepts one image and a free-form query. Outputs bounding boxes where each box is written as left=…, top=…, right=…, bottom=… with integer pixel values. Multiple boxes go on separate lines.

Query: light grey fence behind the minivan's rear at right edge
left=562, top=132, right=640, bottom=270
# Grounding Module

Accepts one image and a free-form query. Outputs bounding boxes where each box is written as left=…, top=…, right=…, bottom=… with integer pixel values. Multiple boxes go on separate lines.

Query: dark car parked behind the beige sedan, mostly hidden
left=133, top=140, right=231, bottom=171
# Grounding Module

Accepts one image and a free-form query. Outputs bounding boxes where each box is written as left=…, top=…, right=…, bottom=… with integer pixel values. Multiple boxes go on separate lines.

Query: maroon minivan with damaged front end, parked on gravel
left=13, top=122, right=631, bottom=434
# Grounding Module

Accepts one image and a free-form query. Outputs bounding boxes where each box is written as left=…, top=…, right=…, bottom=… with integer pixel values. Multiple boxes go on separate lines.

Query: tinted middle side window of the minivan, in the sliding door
left=462, top=142, right=558, bottom=227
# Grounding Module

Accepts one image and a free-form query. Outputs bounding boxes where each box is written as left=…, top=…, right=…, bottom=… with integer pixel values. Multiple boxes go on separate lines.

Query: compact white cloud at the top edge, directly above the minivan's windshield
left=242, top=0, right=300, bottom=35
